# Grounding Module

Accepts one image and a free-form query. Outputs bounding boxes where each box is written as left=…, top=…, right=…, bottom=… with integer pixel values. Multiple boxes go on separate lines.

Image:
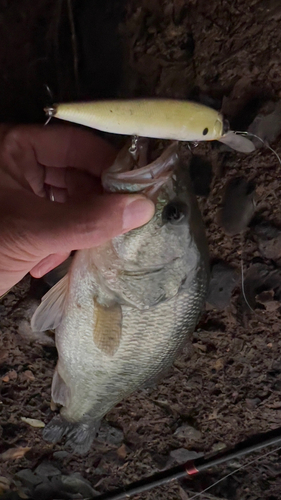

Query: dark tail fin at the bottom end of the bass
left=43, top=415, right=100, bottom=455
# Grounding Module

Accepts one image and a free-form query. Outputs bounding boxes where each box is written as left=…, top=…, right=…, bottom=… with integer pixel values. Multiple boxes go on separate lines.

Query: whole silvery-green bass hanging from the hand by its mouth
left=31, top=139, right=209, bottom=454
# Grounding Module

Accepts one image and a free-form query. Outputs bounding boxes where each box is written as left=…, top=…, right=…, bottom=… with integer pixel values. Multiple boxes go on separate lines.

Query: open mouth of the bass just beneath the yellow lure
left=102, top=138, right=179, bottom=198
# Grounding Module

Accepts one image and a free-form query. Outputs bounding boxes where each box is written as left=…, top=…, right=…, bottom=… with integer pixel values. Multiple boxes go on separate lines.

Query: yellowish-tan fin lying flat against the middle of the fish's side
left=93, top=300, right=122, bottom=356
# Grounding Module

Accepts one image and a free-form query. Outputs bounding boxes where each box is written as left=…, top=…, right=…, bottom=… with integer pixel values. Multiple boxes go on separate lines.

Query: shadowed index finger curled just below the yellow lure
left=3, top=125, right=116, bottom=177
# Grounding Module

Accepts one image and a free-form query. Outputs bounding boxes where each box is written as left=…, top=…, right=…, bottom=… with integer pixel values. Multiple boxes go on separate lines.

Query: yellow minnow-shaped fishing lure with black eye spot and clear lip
left=45, top=99, right=255, bottom=153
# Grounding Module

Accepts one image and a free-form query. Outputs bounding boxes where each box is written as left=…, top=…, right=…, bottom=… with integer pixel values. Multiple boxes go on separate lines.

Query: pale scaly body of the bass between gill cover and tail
left=53, top=269, right=207, bottom=423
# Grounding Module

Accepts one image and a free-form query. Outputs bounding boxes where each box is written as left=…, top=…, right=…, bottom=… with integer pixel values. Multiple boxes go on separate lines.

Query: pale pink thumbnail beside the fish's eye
left=123, top=197, right=155, bottom=231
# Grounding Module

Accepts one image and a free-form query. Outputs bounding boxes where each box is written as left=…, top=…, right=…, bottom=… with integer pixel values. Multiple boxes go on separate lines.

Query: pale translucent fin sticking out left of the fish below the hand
left=31, top=275, right=68, bottom=332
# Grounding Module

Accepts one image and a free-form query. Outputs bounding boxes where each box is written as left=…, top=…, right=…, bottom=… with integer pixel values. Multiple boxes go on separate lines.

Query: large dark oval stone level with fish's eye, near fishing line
left=218, top=177, right=256, bottom=235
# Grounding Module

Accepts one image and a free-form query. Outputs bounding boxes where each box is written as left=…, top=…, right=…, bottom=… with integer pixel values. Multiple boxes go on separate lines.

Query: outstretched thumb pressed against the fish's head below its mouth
left=29, top=194, right=155, bottom=258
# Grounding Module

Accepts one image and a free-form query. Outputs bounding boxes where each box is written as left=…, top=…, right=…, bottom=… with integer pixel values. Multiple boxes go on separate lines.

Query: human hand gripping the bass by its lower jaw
left=0, top=125, right=154, bottom=296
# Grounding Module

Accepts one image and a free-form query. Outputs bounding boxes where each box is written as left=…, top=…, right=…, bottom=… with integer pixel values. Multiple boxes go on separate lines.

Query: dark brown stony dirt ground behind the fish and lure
left=0, top=0, right=281, bottom=500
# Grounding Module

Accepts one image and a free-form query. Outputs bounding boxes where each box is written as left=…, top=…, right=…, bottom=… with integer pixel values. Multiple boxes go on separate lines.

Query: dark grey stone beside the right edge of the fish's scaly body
left=207, top=261, right=238, bottom=310
